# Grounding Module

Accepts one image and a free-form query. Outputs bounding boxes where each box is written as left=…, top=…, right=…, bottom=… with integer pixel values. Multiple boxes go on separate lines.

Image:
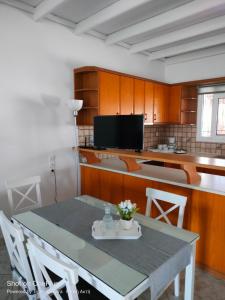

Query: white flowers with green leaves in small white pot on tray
left=116, top=200, right=138, bottom=229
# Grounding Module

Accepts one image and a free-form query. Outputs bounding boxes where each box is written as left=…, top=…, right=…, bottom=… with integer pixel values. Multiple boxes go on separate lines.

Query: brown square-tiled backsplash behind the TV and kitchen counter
left=79, top=125, right=225, bottom=155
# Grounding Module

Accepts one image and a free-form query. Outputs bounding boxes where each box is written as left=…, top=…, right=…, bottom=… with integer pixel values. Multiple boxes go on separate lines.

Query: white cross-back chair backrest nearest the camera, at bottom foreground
left=27, top=238, right=79, bottom=300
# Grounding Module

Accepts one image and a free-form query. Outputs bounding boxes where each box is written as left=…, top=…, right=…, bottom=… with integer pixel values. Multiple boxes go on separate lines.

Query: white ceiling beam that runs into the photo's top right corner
left=106, top=0, right=225, bottom=45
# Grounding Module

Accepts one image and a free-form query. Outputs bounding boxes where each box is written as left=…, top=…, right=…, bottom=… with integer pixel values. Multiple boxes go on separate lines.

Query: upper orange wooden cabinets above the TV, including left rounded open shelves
left=74, top=67, right=179, bottom=125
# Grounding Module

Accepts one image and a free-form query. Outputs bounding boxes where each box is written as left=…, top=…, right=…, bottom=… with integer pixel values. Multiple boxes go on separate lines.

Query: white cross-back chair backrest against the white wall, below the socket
left=5, top=176, right=42, bottom=214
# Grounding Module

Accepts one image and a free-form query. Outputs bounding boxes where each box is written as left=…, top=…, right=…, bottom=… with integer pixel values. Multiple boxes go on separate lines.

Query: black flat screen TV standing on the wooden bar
left=94, top=115, right=144, bottom=151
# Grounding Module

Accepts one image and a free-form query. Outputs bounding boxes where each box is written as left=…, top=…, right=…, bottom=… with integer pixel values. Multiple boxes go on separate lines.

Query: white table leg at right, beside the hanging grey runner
left=184, top=242, right=196, bottom=300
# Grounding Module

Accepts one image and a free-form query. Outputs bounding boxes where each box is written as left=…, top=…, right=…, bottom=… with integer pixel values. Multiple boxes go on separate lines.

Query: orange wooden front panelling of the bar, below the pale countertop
left=81, top=166, right=225, bottom=277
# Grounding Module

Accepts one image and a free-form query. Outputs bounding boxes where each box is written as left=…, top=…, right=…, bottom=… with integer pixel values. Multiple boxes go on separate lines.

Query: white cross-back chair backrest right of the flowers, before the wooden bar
left=145, top=188, right=187, bottom=228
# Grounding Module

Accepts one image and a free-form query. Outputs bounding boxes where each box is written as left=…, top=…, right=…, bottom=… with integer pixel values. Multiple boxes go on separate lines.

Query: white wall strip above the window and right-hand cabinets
left=165, top=54, right=225, bottom=83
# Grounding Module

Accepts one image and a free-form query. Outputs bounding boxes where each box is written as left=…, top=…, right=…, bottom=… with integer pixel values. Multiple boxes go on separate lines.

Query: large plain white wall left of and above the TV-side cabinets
left=0, top=4, right=164, bottom=213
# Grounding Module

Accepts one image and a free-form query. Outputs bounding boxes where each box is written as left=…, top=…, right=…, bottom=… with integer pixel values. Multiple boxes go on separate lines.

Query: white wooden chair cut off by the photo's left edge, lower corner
left=0, top=211, right=36, bottom=300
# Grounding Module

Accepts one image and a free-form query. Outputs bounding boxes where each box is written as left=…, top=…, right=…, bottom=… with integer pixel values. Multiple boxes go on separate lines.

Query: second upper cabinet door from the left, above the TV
left=120, top=76, right=134, bottom=115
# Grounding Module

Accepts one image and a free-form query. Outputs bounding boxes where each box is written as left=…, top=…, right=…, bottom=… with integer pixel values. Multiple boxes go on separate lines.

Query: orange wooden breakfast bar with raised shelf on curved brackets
left=80, top=148, right=225, bottom=278
